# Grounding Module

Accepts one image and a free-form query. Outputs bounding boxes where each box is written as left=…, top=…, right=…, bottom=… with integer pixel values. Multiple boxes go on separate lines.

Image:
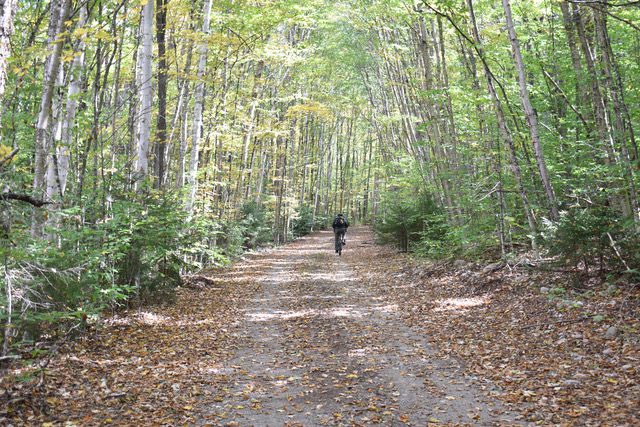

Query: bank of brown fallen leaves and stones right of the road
left=358, top=246, right=640, bottom=425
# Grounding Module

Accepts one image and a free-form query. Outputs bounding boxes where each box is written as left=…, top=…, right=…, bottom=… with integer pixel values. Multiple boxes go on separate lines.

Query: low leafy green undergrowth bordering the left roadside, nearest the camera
left=0, top=192, right=227, bottom=352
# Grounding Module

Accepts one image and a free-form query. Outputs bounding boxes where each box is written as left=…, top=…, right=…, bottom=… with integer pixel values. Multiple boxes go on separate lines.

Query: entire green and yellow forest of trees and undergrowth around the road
left=0, top=0, right=640, bottom=424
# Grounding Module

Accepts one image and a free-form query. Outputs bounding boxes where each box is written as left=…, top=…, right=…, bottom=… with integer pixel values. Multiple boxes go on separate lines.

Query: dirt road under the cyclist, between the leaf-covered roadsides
left=198, top=228, right=515, bottom=426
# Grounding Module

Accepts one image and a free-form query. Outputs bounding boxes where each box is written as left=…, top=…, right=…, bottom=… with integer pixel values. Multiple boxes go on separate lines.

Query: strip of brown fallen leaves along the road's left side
left=0, top=255, right=259, bottom=425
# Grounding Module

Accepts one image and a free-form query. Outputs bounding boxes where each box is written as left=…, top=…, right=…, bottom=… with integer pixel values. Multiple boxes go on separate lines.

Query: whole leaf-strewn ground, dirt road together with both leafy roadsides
left=0, top=228, right=640, bottom=426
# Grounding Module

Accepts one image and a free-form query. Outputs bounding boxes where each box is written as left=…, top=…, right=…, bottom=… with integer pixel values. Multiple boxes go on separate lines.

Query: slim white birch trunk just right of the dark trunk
left=187, top=0, right=212, bottom=212
